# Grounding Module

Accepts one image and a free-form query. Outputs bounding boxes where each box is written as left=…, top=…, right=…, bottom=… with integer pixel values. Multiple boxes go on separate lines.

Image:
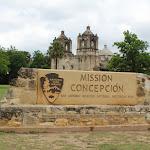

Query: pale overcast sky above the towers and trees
left=0, top=0, right=150, bottom=53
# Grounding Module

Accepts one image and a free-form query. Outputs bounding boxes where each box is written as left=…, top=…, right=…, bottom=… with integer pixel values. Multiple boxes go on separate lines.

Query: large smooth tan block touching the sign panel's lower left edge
left=19, top=91, right=36, bottom=104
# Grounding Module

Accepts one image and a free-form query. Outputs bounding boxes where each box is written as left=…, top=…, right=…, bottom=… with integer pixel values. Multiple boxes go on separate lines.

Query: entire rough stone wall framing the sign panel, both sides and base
left=0, top=68, right=150, bottom=127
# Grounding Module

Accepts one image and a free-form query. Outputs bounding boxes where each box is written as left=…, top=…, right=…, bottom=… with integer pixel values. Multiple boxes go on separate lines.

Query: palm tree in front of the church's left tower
left=47, top=41, right=65, bottom=69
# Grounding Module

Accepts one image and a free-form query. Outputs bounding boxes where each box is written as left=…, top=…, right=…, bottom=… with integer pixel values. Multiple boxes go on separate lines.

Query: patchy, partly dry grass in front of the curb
left=0, top=131, right=150, bottom=150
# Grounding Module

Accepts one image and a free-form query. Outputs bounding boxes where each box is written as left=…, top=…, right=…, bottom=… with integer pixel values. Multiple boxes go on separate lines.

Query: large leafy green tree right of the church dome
left=107, top=30, right=150, bottom=72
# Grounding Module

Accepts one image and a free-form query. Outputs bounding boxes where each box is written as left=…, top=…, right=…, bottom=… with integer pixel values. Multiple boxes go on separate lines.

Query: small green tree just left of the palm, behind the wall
left=30, top=50, right=50, bottom=69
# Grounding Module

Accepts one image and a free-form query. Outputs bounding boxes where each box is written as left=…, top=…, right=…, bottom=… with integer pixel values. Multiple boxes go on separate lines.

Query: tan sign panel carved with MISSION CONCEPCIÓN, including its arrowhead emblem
left=37, top=69, right=137, bottom=105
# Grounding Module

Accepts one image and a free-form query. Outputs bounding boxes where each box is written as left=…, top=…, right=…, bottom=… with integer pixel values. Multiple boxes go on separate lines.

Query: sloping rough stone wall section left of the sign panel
left=1, top=68, right=37, bottom=105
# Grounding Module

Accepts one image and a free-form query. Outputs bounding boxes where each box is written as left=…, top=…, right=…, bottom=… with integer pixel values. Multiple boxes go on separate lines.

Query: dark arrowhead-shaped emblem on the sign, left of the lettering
left=41, top=73, right=63, bottom=103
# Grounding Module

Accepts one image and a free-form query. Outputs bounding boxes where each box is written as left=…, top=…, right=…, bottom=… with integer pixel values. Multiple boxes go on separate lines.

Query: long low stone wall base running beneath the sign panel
left=0, top=105, right=150, bottom=127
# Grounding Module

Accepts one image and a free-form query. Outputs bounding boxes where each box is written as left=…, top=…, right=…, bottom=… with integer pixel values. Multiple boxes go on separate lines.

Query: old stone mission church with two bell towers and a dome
left=51, top=26, right=113, bottom=71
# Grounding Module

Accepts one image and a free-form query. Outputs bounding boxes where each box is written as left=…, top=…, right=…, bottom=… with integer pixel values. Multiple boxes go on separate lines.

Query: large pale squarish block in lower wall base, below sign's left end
left=23, top=113, right=39, bottom=126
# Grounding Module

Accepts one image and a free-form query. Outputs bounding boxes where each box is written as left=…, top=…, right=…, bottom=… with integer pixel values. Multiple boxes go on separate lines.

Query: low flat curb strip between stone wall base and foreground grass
left=0, top=124, right=150, bottom=133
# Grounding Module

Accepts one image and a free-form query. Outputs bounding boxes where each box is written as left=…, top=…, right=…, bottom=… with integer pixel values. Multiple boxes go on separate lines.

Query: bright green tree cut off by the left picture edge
left=0, top=48, right=10, bottom=75
